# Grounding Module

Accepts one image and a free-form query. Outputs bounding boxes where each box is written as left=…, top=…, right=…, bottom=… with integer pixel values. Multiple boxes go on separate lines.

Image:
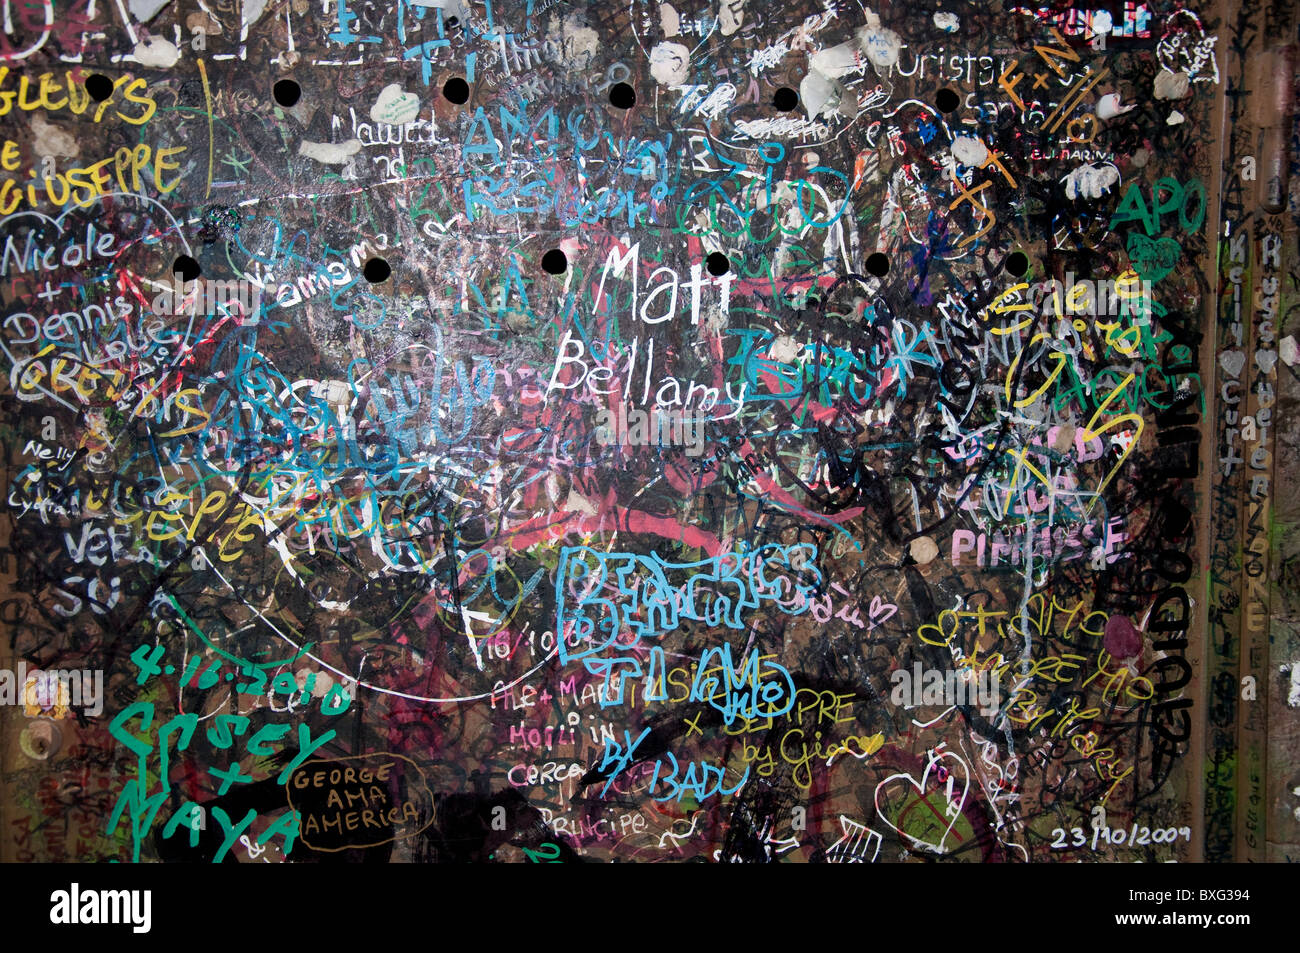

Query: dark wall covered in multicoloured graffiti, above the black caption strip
left=0, top=0, right=1300, bottom=863
